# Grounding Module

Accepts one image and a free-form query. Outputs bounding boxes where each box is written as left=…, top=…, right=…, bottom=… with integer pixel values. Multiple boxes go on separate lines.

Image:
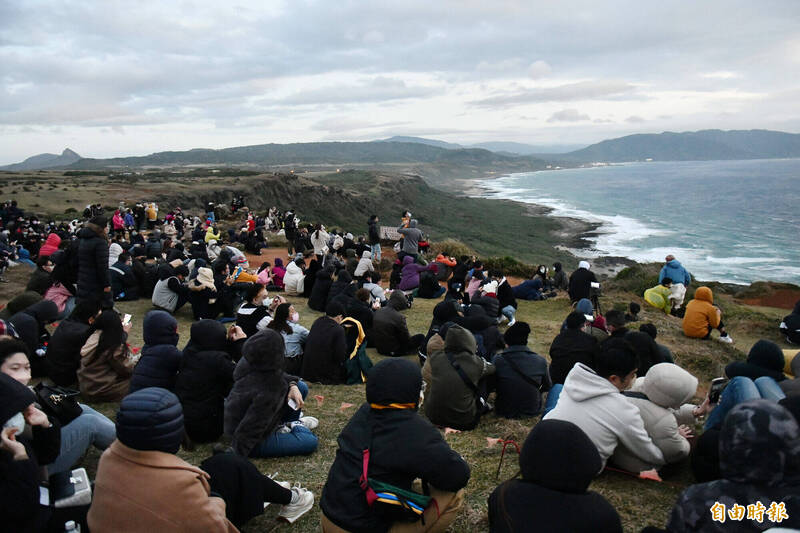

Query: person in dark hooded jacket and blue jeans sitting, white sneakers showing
left=225, top=329, right=319, bottom=457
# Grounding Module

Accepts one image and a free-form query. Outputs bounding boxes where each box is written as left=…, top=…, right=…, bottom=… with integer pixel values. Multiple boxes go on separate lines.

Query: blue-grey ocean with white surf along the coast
left=481, top=159, right=800, bottom=284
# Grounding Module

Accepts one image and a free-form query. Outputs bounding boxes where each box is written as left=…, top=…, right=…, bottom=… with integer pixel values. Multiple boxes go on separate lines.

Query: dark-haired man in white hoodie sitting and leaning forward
left=544, top=338, right=664, bottom=473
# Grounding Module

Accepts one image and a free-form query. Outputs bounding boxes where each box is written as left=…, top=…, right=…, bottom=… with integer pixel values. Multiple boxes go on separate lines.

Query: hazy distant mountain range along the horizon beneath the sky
left=0, top=130, right=800, bottom=171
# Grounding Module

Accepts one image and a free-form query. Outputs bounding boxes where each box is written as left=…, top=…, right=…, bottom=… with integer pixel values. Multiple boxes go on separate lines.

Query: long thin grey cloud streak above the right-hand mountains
left=473, top=81, right=635, bottom=107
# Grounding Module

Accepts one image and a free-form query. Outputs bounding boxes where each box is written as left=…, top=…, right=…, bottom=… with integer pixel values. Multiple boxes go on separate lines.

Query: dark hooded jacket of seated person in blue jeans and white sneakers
left=225, top=329, right=298, bottom=457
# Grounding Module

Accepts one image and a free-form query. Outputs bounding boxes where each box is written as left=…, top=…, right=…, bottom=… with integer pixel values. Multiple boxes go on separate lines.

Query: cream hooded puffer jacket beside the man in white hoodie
left=613, top=363, right=697, bottom=472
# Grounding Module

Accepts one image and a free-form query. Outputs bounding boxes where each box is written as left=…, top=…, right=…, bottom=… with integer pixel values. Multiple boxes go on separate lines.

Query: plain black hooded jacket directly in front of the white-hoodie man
left=489, top=420, right=622, bottom=533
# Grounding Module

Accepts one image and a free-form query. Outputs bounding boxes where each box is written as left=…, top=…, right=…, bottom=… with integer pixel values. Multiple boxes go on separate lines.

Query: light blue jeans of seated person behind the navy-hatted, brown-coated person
left=47, top=404, right=117, bottom=474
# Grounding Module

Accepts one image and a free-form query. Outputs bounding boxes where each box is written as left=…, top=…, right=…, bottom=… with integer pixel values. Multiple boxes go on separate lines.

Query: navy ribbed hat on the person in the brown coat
left=117, top=387, right=183, bottom=453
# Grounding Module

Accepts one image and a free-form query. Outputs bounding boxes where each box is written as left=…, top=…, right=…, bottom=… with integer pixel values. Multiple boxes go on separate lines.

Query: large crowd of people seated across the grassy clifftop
left=0, top=197, right=800, bottom=533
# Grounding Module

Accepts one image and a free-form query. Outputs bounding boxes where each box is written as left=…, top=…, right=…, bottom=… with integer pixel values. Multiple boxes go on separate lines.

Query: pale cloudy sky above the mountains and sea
left=0, top=0, right=800, bottom=164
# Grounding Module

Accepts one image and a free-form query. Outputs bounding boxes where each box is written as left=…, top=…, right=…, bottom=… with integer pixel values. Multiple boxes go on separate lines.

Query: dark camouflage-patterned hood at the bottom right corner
left=719, top=399, right=800, bottom=486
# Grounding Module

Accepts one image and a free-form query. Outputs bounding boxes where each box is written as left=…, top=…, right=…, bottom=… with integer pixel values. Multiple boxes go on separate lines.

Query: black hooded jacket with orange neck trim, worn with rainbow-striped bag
left=320, top=359, right=470, bottom=533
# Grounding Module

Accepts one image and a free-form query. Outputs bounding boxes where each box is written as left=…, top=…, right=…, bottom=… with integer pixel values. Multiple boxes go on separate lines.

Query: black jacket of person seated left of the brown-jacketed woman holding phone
left=45, top=318, right=90, bottom=387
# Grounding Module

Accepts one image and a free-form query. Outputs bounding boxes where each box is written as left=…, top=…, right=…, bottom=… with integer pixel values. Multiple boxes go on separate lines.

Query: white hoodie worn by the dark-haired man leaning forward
left=544, top=363, right=664, bottom=473
